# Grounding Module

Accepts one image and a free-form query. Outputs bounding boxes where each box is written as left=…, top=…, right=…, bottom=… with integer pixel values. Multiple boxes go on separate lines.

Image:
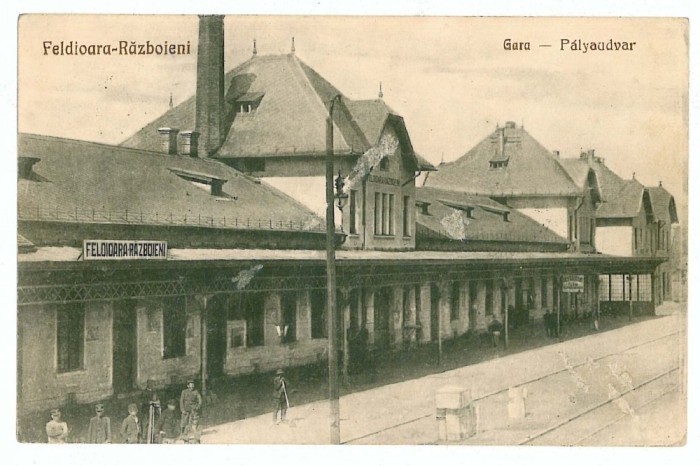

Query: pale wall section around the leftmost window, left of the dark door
left=17, top=302, right=112, bottom=411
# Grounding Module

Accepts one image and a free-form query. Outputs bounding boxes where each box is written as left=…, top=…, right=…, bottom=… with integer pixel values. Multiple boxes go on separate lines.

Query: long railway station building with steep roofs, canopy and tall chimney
left=17, top=17, right=672, bottom=412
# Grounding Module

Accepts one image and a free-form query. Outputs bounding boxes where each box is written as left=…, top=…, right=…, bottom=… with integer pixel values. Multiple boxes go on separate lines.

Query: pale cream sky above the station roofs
left=18, top=15, right=688, bottom=220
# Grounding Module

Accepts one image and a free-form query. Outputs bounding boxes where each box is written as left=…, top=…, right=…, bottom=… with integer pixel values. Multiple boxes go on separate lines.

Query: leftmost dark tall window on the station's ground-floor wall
left=56, top=304, right=85, bottom=372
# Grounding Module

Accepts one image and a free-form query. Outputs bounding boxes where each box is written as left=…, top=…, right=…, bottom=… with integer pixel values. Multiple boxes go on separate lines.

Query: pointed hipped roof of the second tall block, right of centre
left=426, top=122, right=581, bottom=197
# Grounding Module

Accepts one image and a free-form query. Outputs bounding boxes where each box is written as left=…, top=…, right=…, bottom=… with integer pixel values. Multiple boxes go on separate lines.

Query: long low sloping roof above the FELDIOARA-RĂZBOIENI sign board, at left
left=18, top=134, right=322, bottom=227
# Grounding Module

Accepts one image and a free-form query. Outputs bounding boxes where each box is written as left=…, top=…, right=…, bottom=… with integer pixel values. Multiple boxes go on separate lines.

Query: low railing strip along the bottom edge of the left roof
left=17, top=206, right=330, bottom=232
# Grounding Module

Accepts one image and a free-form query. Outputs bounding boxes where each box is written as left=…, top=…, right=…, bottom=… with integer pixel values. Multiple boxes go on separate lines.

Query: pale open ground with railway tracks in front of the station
left=202, top=312, right=687, bottom=445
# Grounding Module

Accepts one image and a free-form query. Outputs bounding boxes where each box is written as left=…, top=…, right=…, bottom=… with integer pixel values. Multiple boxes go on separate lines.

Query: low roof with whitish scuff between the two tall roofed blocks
left=416, top=187, right=567, bottom=244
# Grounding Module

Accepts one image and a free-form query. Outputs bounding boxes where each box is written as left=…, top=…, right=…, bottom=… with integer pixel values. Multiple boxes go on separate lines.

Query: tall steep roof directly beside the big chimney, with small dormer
left=122, top=54, right=420, bottom=165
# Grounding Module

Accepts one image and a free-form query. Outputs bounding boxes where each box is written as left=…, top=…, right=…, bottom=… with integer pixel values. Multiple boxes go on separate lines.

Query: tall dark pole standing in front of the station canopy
left=326, top=95, right=340, bottom=445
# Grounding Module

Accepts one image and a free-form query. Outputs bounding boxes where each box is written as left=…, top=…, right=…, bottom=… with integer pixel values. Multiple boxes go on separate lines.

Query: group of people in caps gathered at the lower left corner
left=46, top=380, right=202, bottom=444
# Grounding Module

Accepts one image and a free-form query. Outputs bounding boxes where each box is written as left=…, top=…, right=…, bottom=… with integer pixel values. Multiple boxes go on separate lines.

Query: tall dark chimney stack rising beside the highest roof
left=195, top=15, right=225, bottom=157
